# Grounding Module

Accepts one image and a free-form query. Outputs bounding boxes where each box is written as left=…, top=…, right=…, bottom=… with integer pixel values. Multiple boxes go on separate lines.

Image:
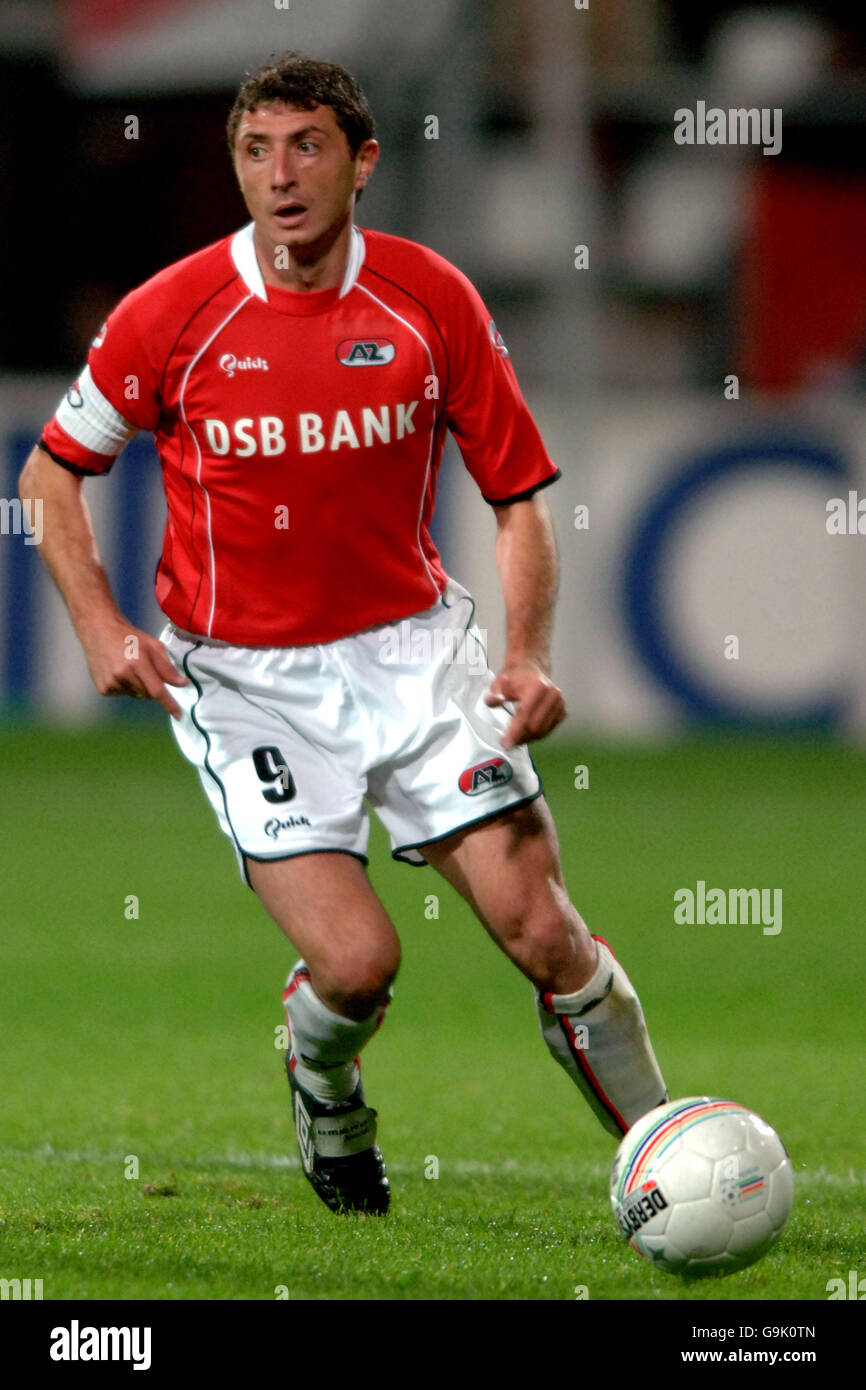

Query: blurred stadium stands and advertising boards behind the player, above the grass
left=0, top=0, right=866, bottom=737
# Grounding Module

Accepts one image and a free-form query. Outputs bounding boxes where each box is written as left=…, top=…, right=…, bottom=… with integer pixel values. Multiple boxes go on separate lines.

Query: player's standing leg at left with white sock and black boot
left=246, top=853, right=400, bottom=1213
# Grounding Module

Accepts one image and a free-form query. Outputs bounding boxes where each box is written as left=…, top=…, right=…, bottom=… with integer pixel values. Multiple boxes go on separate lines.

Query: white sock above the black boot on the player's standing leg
left=282, top=960, right=388, bottom=1102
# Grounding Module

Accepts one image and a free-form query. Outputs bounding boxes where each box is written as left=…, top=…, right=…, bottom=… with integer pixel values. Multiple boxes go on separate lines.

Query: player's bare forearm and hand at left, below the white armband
left=18, top=445, right=189, bottom=719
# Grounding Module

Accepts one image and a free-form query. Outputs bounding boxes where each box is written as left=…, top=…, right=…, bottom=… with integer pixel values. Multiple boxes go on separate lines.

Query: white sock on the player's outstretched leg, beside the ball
left=535, top=937, right=667, bottom=1138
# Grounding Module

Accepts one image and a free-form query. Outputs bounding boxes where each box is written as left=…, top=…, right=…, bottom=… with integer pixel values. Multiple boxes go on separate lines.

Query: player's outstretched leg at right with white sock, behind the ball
left=424, top=798, right=667, bottom=1138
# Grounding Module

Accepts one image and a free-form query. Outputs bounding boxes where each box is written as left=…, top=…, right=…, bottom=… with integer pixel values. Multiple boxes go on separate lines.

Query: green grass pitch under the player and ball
left=0, top=720, right=866, bottom=1300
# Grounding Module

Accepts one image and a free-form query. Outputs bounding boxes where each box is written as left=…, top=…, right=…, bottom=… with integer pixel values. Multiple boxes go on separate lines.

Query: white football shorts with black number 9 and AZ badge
left=160, top=580, right=542, bottom=878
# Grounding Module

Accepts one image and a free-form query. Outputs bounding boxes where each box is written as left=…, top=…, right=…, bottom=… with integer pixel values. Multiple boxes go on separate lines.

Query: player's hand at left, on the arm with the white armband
left=78, top=617, right=189, bottom=719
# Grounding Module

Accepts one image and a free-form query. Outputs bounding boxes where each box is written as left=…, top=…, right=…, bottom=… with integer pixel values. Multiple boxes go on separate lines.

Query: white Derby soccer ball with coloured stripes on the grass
left=610, top=1095, right=794, bottom=1275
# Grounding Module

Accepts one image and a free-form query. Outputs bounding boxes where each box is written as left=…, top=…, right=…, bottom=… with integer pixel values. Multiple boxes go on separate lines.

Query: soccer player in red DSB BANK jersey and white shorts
left=21, top=54, right=666, bottom=1212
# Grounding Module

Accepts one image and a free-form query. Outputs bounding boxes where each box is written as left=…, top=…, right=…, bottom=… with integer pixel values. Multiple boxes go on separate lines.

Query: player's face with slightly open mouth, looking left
left=235, top=101, right=378, bottom=254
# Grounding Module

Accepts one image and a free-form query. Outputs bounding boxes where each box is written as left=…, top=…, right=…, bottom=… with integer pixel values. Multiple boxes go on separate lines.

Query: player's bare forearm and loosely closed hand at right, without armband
left=485, top=493, right=566, bottom=748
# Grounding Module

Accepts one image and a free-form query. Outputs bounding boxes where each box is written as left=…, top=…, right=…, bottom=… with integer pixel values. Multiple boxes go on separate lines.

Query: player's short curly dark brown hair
left=225, top=53, right=375, bottom=175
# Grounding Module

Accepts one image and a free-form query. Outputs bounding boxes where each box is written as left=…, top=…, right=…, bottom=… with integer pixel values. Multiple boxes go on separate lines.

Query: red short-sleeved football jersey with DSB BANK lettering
left=40, top=224, right=559, bottom=646
